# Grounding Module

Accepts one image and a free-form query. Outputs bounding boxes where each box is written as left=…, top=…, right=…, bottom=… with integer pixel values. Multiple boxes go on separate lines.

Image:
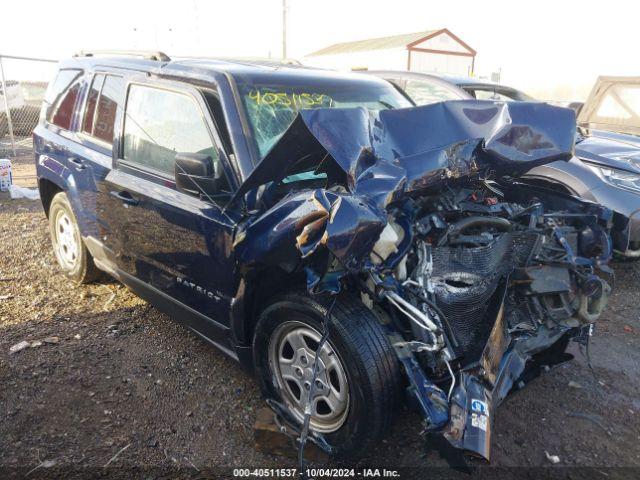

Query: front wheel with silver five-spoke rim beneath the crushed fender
left=253, top=293, right=401, bottom=458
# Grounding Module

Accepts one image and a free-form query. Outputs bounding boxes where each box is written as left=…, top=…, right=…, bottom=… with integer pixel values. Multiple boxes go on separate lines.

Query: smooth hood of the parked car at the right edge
left=576, top=135, right=640, bottom=173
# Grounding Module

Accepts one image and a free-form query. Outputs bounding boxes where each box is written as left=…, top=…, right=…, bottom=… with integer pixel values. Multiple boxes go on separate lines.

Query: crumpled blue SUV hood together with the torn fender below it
left=236, top=101, right=575, bottom=292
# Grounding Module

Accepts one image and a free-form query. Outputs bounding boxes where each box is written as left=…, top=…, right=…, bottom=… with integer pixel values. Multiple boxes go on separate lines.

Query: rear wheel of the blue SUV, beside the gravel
left=49, top=192, right=100, bottom=284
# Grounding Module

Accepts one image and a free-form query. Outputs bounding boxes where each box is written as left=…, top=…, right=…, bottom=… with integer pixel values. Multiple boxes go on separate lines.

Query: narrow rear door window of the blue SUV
left=82, top=74, right=124, bottom=144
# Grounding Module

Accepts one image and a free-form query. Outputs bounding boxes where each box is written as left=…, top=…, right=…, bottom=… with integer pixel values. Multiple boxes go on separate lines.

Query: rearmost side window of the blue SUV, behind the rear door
left=45, top=70, right=82, bottom=130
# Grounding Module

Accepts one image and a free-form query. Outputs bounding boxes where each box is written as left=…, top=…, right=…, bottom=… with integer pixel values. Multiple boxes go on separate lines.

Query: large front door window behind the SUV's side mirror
left=123, top=85, right=224, bottom=178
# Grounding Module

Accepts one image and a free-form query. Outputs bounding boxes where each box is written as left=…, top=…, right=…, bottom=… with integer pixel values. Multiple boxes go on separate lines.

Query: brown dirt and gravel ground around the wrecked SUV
left=0, top=157, right=640, bottom=478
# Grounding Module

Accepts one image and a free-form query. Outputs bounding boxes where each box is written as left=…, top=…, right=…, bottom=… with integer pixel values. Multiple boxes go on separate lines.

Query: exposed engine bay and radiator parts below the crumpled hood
left=372, top=182, right=611, bottom=377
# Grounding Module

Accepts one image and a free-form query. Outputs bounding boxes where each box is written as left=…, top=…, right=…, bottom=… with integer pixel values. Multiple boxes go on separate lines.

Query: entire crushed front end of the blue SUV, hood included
left=235, top=101, right=612, bottom=460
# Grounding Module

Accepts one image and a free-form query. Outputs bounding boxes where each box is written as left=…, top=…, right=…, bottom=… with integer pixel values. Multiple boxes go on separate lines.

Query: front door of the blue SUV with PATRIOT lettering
left=106, top=81, right=236, bottom=346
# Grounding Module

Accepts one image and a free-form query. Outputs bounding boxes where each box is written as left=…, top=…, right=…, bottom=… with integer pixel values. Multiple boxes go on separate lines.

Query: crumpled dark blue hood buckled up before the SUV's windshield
left=231, top=100, right=576, bottom=207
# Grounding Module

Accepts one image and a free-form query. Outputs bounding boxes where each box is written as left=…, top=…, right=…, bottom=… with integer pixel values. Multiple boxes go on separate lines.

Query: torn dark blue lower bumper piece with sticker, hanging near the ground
left=399, top=284, right=591, bottom=461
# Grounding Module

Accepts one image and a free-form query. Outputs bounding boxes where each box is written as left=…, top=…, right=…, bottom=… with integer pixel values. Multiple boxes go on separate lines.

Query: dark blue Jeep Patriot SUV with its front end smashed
left=34, top=54, right=612, bottom=459
